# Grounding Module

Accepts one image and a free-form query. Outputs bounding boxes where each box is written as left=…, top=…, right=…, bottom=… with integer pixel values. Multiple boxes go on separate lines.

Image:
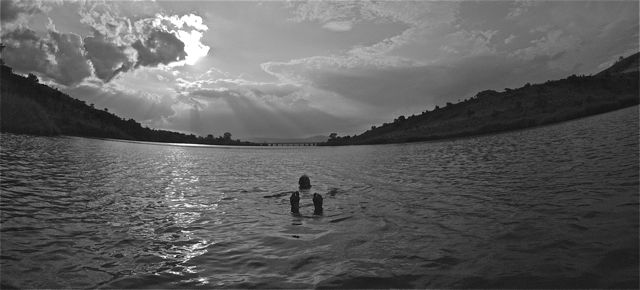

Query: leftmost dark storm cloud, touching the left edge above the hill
left=2, top=28, right=91, bottom=85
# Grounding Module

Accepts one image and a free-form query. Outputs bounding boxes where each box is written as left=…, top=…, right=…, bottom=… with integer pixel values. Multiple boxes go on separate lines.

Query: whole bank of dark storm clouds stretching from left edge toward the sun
left=2, top=23, right=187, bottom=86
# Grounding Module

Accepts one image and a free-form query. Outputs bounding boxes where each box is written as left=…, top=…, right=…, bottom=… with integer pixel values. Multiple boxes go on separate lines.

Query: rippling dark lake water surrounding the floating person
left=0, top=107, right=639, bottom=288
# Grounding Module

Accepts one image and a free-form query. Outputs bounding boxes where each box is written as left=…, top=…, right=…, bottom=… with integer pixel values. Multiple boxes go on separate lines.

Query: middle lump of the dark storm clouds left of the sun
left=84, top=30, right=132, bottom=82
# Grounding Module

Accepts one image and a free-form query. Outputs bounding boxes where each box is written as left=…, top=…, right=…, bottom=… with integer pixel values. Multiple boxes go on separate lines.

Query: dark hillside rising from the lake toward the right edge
left=321, top=53, right=639, bottom=145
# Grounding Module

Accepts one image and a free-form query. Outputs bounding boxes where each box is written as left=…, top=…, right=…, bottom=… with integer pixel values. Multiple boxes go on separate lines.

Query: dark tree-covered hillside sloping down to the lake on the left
left=0, top=65, right=257, bottom=145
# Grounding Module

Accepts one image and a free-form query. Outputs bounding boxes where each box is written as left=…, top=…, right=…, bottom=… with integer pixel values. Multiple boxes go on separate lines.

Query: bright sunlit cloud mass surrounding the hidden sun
left=80, top=2, right=210, bottom=74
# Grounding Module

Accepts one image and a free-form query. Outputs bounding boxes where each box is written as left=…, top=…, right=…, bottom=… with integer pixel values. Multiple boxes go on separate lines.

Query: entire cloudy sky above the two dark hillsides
left=0, top=0, right=640, bottom=139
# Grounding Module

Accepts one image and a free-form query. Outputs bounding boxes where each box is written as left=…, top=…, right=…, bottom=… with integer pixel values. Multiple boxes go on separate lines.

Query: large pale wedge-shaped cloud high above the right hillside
left=272, top=1, right=637, bottom=125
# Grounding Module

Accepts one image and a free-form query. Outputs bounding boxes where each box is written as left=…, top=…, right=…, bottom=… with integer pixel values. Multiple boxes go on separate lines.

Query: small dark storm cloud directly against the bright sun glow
left=131, top=30, right=187, bottom=67
